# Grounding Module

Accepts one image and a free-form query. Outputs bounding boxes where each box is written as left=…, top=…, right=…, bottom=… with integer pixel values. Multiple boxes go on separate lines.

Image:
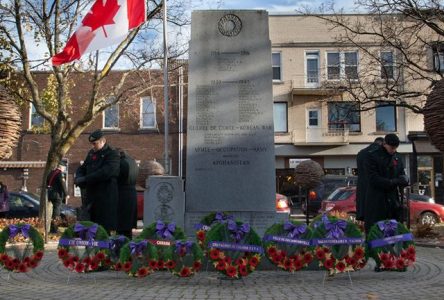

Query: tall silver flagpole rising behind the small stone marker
left=163, top=0, right=170, bottom=174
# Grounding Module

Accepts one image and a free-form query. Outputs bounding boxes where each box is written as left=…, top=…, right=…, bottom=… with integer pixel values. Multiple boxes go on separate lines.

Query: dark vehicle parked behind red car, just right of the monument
left=301, top=175, right=358, bottom=216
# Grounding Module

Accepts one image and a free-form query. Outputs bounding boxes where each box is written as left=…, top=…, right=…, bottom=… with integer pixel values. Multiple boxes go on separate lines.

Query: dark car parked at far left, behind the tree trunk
left=0, top=191, right=76, bottom=220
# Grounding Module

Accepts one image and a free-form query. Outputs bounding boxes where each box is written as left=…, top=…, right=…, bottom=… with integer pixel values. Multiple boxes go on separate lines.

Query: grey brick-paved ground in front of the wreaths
left=0, top=247, right=444, bottom=300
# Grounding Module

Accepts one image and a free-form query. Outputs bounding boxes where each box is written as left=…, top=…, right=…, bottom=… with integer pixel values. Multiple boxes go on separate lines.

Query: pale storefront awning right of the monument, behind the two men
left=274, top=143, right=413, bottom=157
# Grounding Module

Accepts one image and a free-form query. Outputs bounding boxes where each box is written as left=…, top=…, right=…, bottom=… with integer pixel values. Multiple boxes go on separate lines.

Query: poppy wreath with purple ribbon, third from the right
left=263, top=221, right=313, bottom=272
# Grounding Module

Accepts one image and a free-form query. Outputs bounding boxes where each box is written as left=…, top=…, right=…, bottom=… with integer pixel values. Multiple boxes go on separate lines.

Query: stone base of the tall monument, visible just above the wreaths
left=185, top=211, right=288, bottom=237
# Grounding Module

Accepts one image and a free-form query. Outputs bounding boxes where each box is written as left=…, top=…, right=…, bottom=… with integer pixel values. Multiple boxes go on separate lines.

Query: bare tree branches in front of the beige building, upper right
left=304, top=0, right=444, bottom=113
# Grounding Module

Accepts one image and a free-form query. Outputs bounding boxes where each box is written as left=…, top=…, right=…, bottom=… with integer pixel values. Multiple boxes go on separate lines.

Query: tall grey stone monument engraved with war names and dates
left=185, top=10, right=276, bottom=237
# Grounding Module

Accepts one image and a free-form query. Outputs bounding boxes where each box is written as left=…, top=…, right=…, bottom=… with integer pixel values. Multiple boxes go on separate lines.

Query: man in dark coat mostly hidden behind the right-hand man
left=356, top=137, right=384, bottom=221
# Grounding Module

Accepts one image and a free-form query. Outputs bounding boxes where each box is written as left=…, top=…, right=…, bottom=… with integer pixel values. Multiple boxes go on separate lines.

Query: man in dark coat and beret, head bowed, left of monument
left=74, top=130, right=120, bottom=233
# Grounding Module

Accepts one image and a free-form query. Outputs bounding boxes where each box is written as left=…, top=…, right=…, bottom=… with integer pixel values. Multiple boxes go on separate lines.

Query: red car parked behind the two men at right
left=319, top=187, right=444, bottom=224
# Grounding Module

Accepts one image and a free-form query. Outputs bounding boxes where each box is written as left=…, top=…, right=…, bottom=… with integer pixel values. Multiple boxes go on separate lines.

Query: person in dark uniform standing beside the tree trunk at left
left=46, top=161, right=68, bottom=233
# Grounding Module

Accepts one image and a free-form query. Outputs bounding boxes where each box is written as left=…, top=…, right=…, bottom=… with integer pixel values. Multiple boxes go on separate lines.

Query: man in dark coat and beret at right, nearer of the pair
left=364, top=133, right=408, bottom=233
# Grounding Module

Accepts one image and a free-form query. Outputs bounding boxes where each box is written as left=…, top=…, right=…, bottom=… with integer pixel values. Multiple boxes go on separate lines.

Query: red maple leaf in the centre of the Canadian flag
left=82, top=0, right=120, bottom=37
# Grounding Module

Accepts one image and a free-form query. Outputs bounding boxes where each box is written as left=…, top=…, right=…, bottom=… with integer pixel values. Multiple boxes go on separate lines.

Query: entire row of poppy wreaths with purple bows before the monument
left=0, top=213, right=415, bottom=278
